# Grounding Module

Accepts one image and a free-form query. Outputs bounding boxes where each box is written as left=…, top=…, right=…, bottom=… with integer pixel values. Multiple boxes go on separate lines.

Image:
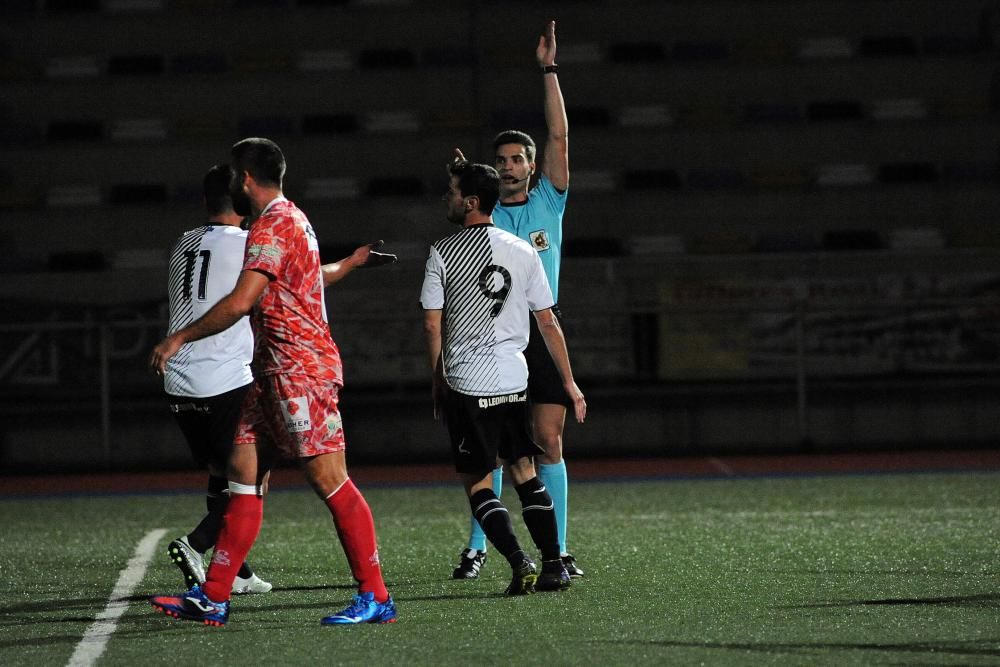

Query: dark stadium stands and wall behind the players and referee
left=0, top=0, right=1000, bottom=472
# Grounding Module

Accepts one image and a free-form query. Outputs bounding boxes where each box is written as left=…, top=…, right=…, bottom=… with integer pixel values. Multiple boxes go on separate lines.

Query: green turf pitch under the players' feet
left=0, top=473, right=1000, bottom=666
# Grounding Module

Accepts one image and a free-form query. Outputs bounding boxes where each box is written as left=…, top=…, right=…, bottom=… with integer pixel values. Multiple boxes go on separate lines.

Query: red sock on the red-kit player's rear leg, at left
left=202, top=493, right=264, bottom=602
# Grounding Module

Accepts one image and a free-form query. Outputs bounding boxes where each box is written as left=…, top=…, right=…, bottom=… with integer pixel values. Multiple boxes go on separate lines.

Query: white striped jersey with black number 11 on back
left=163, top=225, right=253, bottom=398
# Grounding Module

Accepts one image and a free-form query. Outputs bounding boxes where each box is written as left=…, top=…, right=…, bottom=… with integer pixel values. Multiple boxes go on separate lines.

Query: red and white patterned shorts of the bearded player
left=235, top=375, right=347, bottom=458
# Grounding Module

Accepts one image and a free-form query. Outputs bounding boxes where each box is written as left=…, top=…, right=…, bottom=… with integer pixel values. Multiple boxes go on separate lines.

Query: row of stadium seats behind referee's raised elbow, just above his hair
left=0, top=98, right=1000, bottom=147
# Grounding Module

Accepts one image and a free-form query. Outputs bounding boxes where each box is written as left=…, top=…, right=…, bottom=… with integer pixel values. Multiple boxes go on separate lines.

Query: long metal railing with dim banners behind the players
left=0, top=297, right=1000, bottom=468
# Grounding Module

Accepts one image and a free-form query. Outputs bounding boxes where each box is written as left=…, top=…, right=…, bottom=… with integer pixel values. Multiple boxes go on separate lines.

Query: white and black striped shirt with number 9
left=420, top=224, right=555, bottom=396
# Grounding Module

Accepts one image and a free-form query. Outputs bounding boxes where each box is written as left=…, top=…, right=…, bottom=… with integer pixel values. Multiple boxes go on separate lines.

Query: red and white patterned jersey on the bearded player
left=243, top=197, right=343, bottom=385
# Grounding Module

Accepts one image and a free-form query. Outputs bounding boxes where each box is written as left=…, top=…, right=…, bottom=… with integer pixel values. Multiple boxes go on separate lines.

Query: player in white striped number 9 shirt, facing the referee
left=421, top=161, right=587, bottom=595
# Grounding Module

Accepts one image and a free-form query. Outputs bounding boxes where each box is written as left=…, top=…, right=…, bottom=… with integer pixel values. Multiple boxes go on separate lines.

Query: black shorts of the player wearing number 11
left=167, top=384, right=250, bottom=471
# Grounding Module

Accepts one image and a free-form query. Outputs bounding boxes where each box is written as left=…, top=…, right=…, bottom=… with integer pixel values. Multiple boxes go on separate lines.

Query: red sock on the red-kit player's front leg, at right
left=326, top=480, right=389, bottom=602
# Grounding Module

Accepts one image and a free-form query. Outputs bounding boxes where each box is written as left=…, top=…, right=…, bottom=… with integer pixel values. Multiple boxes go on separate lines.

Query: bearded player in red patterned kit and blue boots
left=150, top=138, right=396, bottom=625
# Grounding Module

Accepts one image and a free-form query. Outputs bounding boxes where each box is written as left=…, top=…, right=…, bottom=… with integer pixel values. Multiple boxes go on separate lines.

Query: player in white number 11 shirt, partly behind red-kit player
left=163, top=165, right=271, bottom=593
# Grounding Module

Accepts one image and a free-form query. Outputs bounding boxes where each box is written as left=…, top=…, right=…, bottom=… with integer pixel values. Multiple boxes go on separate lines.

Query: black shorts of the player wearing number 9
left=444, top=389, right=545, bottom=475
